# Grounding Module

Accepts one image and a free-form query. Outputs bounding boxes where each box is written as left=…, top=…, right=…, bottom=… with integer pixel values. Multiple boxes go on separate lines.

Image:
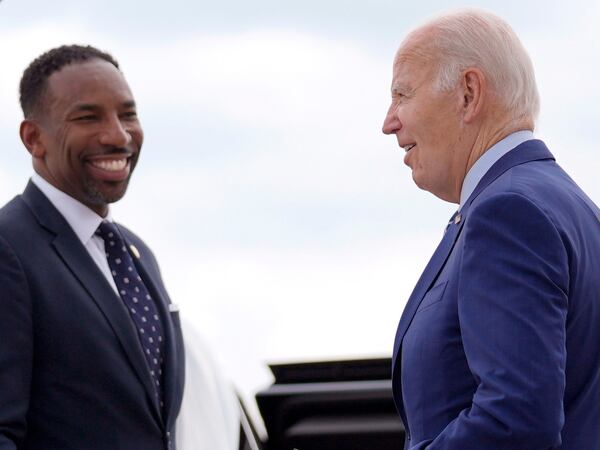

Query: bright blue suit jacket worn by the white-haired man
left=393, top=140, right=600, bottom=450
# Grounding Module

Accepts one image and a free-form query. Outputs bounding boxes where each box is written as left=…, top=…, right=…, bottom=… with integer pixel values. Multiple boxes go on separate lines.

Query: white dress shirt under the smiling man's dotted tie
left=31, top=173, right=119, bottom=295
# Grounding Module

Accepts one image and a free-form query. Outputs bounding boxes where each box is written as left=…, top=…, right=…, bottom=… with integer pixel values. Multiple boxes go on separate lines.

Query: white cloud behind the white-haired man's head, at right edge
left=523, top=4, right=600, bottom=203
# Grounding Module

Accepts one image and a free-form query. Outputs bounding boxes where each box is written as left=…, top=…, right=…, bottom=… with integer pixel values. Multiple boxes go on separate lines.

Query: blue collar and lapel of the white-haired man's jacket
left=392, top=140, right=554, bottom=371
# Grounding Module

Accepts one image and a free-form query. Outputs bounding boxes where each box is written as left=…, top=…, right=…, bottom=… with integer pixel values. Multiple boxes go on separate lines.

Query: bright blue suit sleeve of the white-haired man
left=415, top=193, right=569, bottom=450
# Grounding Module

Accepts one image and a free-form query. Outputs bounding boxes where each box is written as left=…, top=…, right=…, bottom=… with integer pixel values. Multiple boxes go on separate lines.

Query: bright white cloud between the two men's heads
left=116, top=30, right=387, bottom=136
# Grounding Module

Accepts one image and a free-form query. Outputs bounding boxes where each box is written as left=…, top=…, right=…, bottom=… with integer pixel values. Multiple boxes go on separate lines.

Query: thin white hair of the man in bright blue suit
left=409, top=9, right=540, bottom=122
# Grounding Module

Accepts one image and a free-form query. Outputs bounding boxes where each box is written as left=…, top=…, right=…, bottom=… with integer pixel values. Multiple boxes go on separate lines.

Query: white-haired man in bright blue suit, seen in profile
left=383, top=10, right=600, bottom=450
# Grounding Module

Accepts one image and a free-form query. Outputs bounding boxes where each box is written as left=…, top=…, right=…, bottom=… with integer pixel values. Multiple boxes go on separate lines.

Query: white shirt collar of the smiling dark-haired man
left=31, top=173, right=113, bottom=245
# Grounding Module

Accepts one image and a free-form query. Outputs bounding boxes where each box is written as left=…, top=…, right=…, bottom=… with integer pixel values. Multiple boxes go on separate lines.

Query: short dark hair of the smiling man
left=19, top=45, right=119, bottom=118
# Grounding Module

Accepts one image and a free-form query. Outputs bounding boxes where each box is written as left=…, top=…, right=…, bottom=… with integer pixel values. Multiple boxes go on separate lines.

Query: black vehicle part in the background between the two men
left=253, top=358, right=404, bottom=450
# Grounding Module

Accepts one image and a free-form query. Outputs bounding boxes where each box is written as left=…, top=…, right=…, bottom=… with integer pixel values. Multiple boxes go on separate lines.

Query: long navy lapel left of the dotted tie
left=23, top=183, right=161, bottom=426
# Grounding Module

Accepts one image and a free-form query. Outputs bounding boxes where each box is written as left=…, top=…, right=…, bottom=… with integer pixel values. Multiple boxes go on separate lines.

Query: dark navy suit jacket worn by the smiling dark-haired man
left=0, top=183, right=184, bottom=450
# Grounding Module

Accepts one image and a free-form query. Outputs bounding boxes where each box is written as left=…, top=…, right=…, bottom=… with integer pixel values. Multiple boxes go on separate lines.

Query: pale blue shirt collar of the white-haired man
left=458, top=130, right=534, bottom=211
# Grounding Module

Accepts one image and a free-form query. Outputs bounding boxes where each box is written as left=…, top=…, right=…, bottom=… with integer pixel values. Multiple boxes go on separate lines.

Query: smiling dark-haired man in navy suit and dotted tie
left=0, top=46, right=184, bottom=450
